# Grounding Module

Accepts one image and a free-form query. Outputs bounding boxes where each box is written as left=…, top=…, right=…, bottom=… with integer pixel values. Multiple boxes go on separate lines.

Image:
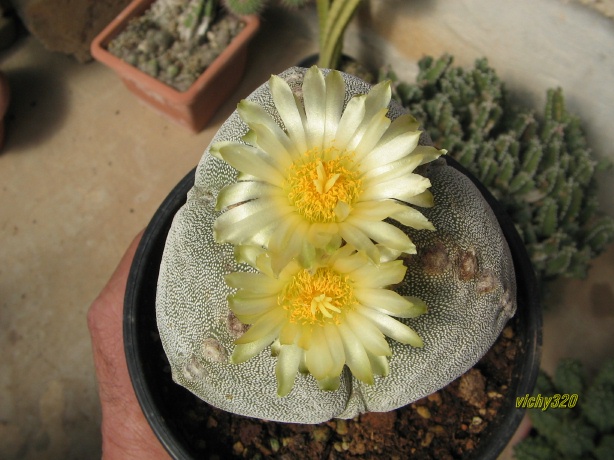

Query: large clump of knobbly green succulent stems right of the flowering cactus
left=380, top=55, right=614, bottom=280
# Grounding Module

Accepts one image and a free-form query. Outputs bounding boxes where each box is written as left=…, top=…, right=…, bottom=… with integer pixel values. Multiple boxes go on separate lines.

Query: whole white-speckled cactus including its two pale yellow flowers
left=156, top=67, right=516, bottom=423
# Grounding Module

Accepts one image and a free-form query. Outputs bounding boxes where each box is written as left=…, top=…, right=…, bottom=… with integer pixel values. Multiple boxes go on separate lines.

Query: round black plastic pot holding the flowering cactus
left=124, top=158, right=542, bottom=459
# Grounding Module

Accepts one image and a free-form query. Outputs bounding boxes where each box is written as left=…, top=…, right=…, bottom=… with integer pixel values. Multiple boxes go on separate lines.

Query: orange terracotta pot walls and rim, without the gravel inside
left=91, top=0, right=260, bottom=132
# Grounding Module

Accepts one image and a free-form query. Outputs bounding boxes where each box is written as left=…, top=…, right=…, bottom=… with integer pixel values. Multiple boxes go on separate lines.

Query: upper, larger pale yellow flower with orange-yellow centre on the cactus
left=211, top=66, right=445, bottom=273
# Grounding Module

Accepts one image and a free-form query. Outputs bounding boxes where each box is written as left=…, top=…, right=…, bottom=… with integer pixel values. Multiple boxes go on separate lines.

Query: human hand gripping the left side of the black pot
left=87, top=233, right=169, bottom=460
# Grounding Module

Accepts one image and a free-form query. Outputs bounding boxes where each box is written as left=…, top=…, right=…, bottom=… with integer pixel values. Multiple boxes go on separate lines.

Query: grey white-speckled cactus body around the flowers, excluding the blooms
left=156, top=68, right=516, bottom=423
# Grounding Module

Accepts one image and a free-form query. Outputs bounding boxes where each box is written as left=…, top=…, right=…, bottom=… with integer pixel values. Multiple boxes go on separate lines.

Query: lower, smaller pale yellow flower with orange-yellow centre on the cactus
left=225, top=245, right=426, bottom=396
